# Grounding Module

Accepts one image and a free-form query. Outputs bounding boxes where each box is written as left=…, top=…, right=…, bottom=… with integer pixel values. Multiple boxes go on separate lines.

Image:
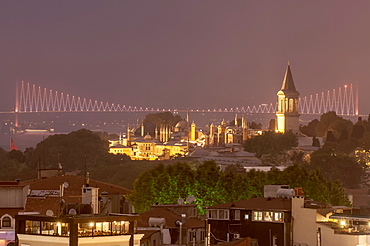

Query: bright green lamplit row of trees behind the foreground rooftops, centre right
left=129, top=161, right=349, bottom=212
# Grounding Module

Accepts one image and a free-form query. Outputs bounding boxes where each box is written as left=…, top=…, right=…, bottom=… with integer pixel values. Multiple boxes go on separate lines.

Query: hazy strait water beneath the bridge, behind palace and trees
left=0, top=112, right=357, bottom=151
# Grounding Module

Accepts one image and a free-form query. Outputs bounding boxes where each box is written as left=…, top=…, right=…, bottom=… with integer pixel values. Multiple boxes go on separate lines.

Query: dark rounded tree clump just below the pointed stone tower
left=244, top=131, right=298, bottom=162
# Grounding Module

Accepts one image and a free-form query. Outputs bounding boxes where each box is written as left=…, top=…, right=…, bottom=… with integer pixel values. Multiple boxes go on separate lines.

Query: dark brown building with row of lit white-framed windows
left=207, top=197, right=292, bottom=246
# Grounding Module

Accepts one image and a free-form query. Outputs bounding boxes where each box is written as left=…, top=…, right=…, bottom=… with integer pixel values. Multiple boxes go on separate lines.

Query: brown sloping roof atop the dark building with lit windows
left=208, top=197, right=292, bottom=211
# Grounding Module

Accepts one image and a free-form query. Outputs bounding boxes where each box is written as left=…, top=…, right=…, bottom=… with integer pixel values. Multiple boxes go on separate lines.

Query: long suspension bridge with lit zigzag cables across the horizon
left=12, top=81, right=359, bottom=116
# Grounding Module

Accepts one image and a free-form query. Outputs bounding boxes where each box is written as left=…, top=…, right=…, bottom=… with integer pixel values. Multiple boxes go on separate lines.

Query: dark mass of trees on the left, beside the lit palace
left=0, top=129, right=163, bottom=189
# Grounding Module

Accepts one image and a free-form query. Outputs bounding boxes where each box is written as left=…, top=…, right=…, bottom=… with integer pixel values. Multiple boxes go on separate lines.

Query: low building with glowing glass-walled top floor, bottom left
left=16, top=214, right=143, bottom=246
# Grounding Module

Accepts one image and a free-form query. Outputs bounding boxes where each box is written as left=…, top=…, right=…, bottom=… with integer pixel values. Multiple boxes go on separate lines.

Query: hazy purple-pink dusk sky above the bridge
left=0, top=0, right=370, bottom=114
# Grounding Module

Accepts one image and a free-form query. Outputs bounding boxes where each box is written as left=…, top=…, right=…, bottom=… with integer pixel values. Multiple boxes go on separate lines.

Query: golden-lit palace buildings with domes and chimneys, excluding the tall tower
left=109, top=115, right=253, bottom=160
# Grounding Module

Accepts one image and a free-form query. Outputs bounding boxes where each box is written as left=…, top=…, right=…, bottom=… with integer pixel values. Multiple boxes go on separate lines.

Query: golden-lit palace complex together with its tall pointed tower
left=109, top=64, right=300, bottom=160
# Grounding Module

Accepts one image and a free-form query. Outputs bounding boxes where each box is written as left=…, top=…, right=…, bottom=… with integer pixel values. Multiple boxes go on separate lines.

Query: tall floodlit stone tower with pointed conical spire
left=276, top=63, right=299, bottom=133
